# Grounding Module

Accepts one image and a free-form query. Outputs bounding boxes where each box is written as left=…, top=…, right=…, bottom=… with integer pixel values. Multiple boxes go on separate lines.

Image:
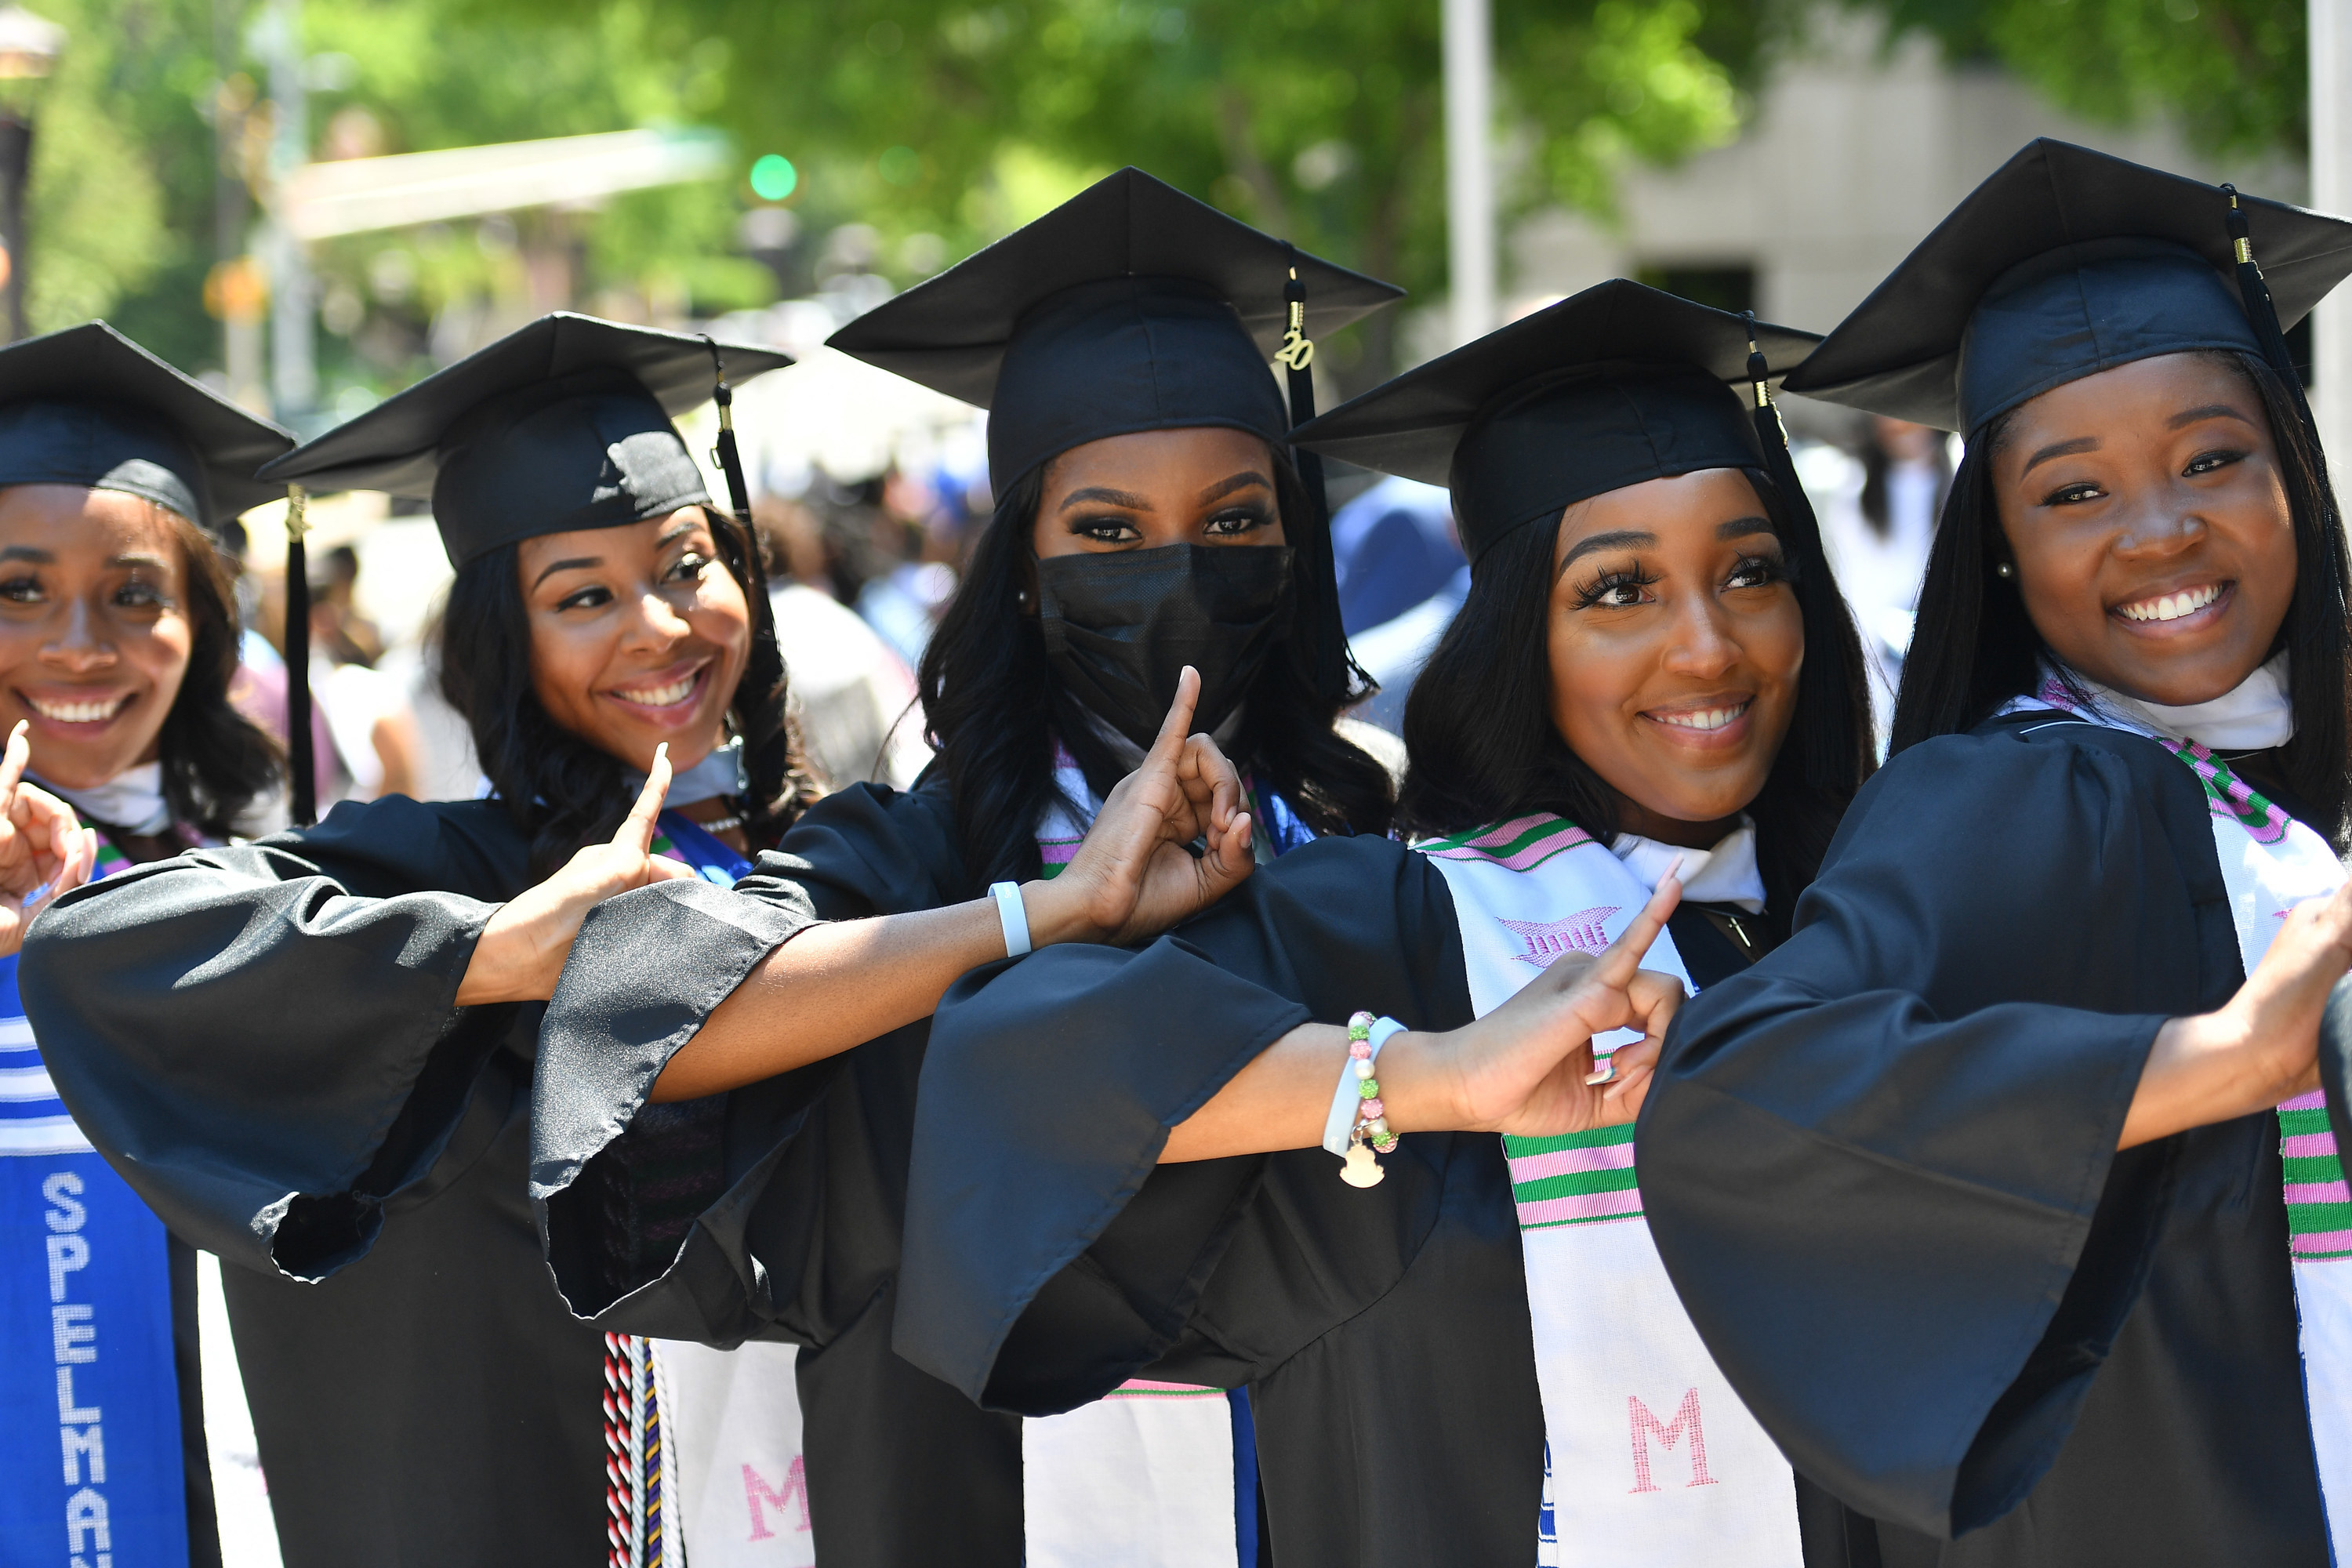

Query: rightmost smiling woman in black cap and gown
left=1642, top=141, right=2352, bottom=1568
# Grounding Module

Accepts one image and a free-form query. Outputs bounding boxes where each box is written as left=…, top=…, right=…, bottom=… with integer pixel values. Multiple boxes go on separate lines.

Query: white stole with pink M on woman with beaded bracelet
left=1416, top=813, right=1804, bottom=1568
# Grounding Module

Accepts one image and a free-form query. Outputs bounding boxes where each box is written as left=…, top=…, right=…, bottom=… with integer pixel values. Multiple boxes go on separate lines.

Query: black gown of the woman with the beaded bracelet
left=896, top=839, right=1863, bottom=1568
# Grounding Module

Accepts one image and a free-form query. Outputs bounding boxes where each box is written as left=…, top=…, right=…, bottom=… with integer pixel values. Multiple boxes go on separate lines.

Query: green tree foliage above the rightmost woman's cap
left=1858, top=0, right=2310, bottom=155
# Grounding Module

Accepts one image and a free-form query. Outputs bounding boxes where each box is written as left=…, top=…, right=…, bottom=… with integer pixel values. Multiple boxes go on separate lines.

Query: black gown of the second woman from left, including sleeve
left=19, top=797, right=604, bottom=1568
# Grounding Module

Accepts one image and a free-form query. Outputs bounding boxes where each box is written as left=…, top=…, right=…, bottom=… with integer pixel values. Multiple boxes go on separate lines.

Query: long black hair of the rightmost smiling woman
left=1889, top=350, right=2352, bottom=851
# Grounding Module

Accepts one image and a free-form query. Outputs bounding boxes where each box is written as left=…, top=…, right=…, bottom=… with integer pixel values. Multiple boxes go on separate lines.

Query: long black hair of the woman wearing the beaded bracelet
left=1397, top=468, right=1870, bottom=933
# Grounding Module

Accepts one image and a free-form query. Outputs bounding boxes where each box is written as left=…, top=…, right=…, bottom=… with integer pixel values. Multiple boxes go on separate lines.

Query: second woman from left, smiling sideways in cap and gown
left=26, top=315, right=1247, bottom=1568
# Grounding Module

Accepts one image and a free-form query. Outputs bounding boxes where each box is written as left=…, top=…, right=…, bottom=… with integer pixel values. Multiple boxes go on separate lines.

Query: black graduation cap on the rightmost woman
left=1788, top=139, right=2352, bottom=433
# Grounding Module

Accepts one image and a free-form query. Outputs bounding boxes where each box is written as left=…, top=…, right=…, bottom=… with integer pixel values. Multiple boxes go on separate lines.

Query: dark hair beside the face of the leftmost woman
left=154, top=508, right=285, bottom=837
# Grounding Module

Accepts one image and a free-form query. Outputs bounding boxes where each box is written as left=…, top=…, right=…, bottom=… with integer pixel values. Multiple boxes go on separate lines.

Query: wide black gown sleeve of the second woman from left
left=19, top=797, right=529, bottom=1279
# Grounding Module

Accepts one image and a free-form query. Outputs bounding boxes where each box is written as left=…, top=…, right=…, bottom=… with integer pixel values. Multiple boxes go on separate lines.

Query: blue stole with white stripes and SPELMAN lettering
left=0, top=841, right=188, bottom=1568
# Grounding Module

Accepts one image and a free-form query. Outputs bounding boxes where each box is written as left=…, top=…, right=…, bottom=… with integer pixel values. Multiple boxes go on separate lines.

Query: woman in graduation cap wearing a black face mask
left=534, top=169, right=1395, bottom=1568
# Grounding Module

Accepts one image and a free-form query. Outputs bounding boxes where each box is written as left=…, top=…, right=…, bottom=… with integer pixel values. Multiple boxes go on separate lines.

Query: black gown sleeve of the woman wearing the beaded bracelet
left=896, top=839, right=1494, bottom=1415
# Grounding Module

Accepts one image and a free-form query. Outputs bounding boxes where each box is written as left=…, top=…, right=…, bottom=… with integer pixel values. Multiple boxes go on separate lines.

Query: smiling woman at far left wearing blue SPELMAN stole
left=0, top=322, right=294, bottom=1563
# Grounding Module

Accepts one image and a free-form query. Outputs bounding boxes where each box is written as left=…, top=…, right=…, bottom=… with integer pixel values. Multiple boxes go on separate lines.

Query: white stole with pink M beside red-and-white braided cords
left=604, top=811, right=795, bottom=1568
